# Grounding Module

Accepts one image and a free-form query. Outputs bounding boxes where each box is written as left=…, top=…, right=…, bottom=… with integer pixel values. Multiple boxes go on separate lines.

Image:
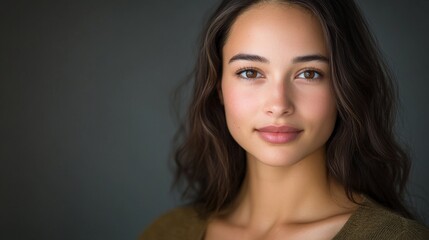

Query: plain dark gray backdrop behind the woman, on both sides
left=0, top=0, right=429, bottom=239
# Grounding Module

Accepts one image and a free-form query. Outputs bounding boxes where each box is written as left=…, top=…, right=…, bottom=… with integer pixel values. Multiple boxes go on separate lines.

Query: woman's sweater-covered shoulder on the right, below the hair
left=335, top=199, right=429, bottom=240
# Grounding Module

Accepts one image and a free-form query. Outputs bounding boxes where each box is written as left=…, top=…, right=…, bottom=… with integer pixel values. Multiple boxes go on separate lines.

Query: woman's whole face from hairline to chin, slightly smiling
left=220, top=3, right=337, bottom=166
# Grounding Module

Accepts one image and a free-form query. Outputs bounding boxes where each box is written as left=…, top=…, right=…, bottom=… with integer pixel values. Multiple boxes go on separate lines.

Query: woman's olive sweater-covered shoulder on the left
left=139, top=206, right=206, bottom=240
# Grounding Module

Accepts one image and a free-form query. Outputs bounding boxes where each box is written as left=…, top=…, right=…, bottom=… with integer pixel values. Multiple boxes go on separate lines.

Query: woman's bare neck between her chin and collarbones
left=224, top=149, right=355, bottom=231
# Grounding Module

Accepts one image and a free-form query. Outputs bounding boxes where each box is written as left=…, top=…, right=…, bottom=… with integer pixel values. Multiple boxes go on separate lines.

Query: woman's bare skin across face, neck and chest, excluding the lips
left=205, top=3, right=361, bottom=240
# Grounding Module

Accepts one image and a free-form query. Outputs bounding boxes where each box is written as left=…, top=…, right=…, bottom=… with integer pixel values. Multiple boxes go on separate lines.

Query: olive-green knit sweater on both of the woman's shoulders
left=140, top=200, right=429, bottom=240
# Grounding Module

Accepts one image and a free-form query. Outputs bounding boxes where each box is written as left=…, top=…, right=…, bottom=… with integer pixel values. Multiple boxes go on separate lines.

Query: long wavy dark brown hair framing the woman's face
left=174, top=0, right=413, bottom=218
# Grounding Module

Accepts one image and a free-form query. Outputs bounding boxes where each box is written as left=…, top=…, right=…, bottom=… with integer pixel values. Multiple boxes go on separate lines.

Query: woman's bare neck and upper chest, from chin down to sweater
left=205, top=149, right=362, bottom=240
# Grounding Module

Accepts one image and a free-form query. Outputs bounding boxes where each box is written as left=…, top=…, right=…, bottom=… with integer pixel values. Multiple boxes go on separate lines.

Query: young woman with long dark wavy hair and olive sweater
left=141, top=0, right=429, bottom=240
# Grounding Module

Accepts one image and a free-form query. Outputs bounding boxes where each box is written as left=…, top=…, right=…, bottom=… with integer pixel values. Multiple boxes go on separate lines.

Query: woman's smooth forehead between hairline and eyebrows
left=223, top=3, right=329, bottom=63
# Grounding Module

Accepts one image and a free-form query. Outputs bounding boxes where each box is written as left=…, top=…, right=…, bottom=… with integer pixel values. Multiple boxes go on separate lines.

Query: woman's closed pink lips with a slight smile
left=256, top=126, right=302, bottom=144
